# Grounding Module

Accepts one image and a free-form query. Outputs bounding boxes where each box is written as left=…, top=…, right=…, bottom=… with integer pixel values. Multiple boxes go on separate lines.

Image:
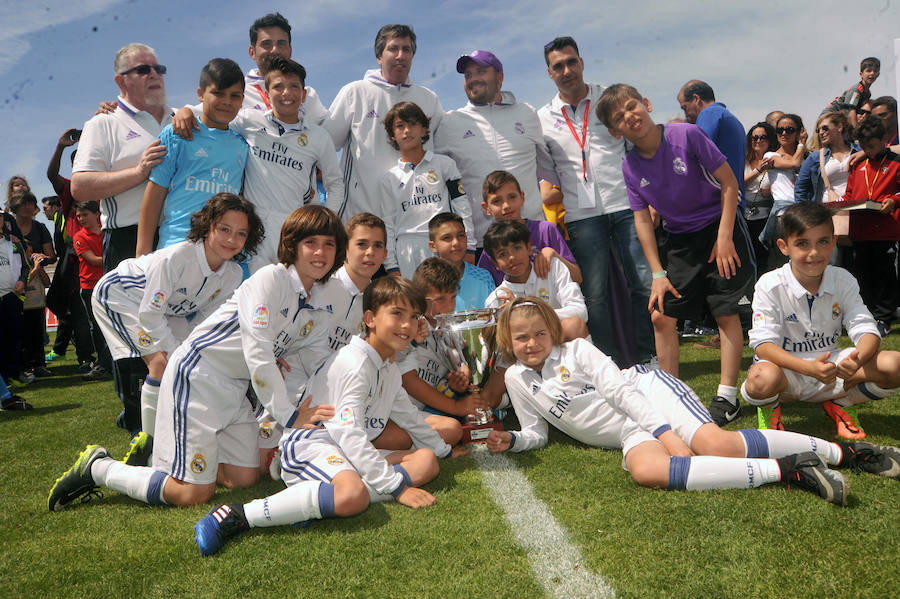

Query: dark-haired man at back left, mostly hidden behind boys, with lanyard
left=244, top=12, right=328, bottom=125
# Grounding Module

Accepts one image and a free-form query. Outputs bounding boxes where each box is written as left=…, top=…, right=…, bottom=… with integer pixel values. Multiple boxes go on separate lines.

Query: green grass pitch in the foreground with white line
left=0, top=329, right=900, bottom=599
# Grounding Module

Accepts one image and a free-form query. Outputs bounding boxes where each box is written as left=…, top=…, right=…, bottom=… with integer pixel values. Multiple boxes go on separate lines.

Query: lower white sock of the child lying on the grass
left=669, top=456, right=781, bottom=491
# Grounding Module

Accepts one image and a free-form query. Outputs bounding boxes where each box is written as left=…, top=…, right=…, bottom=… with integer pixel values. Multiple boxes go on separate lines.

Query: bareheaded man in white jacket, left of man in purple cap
left=322, top=25, right=444, bottom=222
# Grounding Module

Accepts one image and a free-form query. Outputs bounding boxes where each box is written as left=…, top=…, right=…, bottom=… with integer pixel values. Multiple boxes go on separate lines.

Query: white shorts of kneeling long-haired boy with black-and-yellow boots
left=153, top=346, right=259, bottom=485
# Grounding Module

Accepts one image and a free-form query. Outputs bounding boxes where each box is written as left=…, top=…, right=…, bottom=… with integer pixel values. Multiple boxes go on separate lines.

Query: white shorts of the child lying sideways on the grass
left=622, top=366, right=712, bottom=470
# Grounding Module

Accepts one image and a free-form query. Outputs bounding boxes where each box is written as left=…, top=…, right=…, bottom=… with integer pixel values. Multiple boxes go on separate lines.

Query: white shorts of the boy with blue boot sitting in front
left=281, top=429, right=394, bottom=487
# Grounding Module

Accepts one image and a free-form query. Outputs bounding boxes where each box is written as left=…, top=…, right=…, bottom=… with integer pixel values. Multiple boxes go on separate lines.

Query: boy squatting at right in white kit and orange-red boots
left=741, top=202, right=900, bottom=440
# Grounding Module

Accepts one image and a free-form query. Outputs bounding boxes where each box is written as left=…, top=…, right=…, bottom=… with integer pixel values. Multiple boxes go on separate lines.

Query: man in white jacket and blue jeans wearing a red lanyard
left=538, top=37, right=656, bottom=367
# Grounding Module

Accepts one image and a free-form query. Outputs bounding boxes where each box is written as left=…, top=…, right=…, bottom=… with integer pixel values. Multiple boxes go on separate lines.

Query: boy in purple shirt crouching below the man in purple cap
left=478, top=171, right=581, bottom=285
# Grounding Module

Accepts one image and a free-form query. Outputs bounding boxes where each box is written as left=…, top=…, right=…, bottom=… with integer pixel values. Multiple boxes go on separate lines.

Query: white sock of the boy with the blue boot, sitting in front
left=244, top=480, right=334, bottom=528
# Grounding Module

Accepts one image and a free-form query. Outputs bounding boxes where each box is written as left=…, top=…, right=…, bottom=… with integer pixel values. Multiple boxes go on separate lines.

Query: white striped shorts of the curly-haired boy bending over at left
left=91, top=271, right=193, bottom=360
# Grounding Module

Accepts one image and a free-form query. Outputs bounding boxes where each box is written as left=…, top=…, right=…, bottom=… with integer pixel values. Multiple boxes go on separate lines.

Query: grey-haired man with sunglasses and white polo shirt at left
left=72, top=43, right=173, bottom=431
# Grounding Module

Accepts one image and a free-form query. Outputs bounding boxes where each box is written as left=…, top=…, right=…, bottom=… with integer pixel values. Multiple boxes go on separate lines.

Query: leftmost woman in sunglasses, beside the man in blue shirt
left=744, top=122, right=778, bottom=279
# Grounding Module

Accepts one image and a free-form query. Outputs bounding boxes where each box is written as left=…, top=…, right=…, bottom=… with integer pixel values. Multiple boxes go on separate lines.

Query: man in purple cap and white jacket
left=434, top=50, right=550, bottom=247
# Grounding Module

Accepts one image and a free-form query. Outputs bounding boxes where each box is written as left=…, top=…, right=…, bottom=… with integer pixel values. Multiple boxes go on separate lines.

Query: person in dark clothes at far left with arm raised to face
left=43, top=128, right=94, bottom=374
